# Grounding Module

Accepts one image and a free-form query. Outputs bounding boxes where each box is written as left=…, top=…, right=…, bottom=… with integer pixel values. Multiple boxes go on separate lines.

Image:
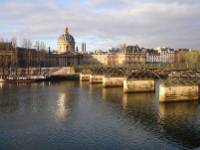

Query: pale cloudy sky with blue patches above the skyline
left=0, top=0, right=200, bottom=50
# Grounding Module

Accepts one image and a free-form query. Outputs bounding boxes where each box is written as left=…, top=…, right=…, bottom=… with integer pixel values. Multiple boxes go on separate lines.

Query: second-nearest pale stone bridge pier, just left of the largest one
left=123, top=79, right=155, bottom=93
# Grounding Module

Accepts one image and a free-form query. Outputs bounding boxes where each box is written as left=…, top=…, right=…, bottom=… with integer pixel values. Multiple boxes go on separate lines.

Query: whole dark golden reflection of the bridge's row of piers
left=90, top=84, right=199, bottom=149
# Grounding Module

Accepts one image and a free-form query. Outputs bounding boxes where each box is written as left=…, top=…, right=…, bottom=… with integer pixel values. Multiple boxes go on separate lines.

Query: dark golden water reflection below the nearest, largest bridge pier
left=158, top=102, right=200, bottom=148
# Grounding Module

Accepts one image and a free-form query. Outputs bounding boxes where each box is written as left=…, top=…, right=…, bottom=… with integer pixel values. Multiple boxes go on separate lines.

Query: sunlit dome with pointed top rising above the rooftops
left=57, top=27, right=75, bottom=54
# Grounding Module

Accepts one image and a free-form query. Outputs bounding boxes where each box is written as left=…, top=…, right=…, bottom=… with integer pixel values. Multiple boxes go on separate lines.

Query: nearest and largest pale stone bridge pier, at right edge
left=159, top=84, right=199, bottom=102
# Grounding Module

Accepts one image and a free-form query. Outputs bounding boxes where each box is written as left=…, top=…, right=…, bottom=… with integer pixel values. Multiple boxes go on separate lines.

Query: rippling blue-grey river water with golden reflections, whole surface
left=0, top=82, right=200, bottom=150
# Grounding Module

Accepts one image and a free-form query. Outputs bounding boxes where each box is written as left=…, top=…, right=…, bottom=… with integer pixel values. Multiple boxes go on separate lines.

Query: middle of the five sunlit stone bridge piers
left=103, top=77, right=125, bottom=87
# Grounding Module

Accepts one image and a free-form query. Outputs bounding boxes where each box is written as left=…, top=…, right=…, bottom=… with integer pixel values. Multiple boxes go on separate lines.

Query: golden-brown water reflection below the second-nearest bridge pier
left=122, top=93, right=158, bottom=134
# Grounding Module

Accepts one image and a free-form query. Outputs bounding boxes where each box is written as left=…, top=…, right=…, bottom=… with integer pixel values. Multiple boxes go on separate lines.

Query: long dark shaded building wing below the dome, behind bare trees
left=17, top=47, right=82, bottom=68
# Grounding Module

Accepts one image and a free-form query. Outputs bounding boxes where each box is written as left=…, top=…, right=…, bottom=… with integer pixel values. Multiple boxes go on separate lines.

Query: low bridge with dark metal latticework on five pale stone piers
left=77, top=67, right=200, bottom=103
